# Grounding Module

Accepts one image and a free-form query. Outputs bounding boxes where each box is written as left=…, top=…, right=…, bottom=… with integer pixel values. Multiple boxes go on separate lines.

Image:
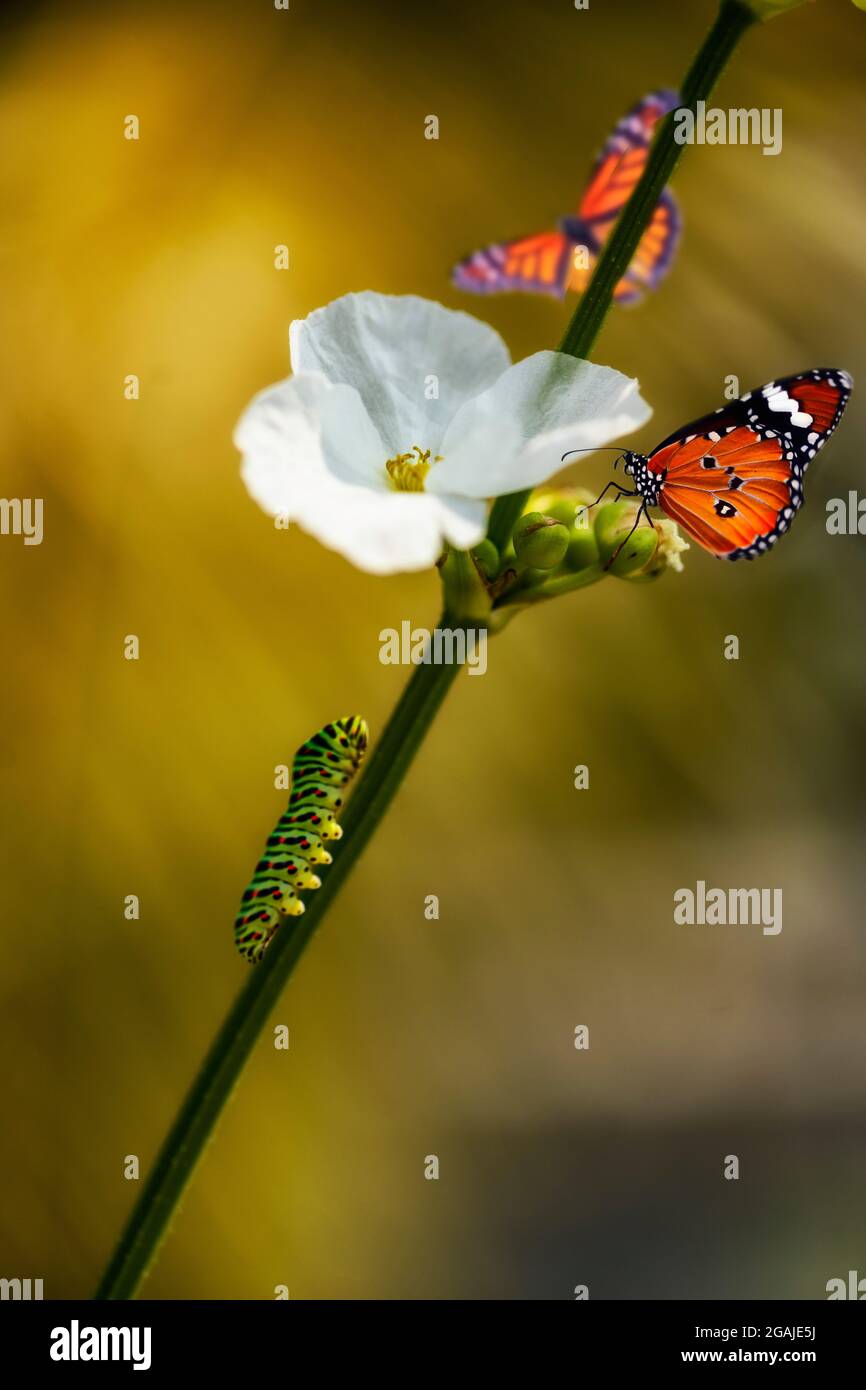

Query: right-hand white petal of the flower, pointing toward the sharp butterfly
left=427, top=352, right=652, bottom=498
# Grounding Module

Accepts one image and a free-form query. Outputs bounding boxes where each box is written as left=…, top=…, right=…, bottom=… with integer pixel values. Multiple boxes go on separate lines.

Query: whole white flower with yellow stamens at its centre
left=235, top=291, right=651, bottom=574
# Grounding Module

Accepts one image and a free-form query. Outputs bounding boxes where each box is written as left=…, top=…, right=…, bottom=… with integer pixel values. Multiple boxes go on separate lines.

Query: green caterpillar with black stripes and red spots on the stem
left=235, top=714, right=367, bottom=965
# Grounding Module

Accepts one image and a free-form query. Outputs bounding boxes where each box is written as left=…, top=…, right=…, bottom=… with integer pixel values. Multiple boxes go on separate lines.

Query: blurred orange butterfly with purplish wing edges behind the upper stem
left=452, top=92, right=680, bottom=304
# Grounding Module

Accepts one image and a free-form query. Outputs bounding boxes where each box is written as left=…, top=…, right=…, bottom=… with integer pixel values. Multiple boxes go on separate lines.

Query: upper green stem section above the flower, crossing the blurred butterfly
left=488, top=0, right=756, bottom=549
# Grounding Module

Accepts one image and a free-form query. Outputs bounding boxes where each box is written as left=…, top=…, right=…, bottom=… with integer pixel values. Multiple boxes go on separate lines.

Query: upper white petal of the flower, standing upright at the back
left=289, top=291, right=510, bottom=457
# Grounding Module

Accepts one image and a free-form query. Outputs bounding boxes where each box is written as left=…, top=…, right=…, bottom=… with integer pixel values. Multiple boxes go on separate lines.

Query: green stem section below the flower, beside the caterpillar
left=95, top=631, right=466, bottom=1298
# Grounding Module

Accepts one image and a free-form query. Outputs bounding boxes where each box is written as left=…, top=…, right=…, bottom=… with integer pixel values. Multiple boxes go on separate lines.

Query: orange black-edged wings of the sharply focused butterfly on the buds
left=648, top=368, right=852, bottom=560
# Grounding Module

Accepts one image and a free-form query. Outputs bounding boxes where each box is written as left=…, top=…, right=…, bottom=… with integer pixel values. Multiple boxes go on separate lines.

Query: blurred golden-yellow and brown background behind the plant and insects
left=0, top=0, right=866, bottom=1298
